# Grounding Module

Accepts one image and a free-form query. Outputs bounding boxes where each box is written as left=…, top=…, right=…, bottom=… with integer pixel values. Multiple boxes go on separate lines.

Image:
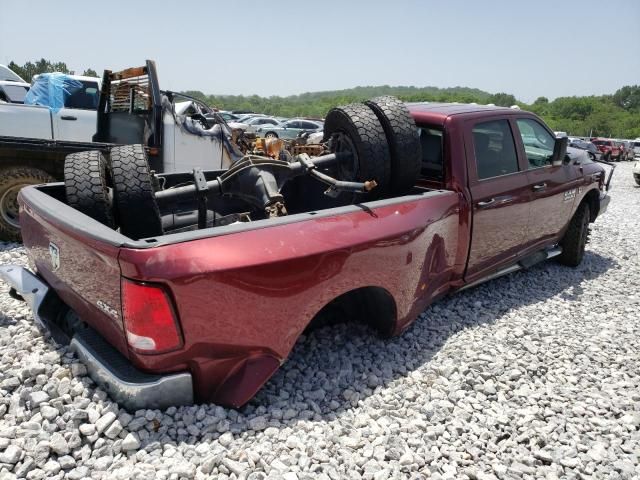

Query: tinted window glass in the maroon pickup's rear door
left=472, top=120, right=519, bottom=180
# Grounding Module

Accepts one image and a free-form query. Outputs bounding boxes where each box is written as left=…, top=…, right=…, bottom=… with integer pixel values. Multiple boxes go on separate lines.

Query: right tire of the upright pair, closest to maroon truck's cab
left=365, top=96, right=422, bottom=195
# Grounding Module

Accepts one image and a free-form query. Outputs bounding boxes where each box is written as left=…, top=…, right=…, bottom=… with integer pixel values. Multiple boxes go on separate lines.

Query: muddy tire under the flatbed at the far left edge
left=0, top=167, right=55, bottom=242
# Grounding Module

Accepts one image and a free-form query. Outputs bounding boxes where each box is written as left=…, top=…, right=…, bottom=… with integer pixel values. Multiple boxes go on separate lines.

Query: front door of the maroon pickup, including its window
left=516, top=118, right=582, bottom=244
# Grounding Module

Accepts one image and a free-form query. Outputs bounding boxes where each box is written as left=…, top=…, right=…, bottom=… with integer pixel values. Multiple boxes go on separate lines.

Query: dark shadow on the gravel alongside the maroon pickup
left=242, top=251, right=618, bottom=426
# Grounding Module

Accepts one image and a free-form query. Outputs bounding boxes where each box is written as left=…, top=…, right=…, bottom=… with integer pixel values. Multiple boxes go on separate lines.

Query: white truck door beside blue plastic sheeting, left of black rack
left=53, top=80, right=99, bottom=142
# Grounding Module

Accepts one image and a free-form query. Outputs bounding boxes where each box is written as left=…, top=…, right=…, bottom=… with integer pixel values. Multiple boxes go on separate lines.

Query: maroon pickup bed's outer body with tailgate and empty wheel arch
left=19, top=183, right=466, bottom=406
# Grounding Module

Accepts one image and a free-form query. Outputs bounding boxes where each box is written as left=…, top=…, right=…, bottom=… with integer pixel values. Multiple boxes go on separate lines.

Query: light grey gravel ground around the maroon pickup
left=0, top=164, right=640, bottom=480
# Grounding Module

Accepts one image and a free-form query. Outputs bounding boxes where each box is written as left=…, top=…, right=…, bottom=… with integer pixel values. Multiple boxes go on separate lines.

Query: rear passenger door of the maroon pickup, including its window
left=465, top=117, right=530, bottom=281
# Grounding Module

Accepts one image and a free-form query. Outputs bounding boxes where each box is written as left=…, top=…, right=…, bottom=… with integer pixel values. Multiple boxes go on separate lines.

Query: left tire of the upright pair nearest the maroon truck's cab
left=324, top=103, right=391, bottom=202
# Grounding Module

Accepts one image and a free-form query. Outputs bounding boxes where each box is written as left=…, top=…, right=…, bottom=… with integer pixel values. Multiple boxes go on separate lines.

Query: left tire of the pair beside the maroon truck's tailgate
left=64, top=150, right=115, bottom=228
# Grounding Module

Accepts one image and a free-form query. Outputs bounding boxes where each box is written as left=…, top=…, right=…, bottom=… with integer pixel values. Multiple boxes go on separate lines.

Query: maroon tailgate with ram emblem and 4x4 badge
left=19, top=184, right=129, bottom=357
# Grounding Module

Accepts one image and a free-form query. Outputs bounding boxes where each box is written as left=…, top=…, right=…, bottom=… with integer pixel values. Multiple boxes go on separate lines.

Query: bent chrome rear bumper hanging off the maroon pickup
left=0, top=265, right=193, bottom=411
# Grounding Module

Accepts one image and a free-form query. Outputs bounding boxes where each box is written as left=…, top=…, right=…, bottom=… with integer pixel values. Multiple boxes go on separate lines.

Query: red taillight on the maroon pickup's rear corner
left=122, top=278, right=182, bottom=353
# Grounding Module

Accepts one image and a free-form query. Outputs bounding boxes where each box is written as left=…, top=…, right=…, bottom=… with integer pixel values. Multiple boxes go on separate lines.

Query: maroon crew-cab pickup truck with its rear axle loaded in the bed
left=0, top=103, right=611, bottom=409
